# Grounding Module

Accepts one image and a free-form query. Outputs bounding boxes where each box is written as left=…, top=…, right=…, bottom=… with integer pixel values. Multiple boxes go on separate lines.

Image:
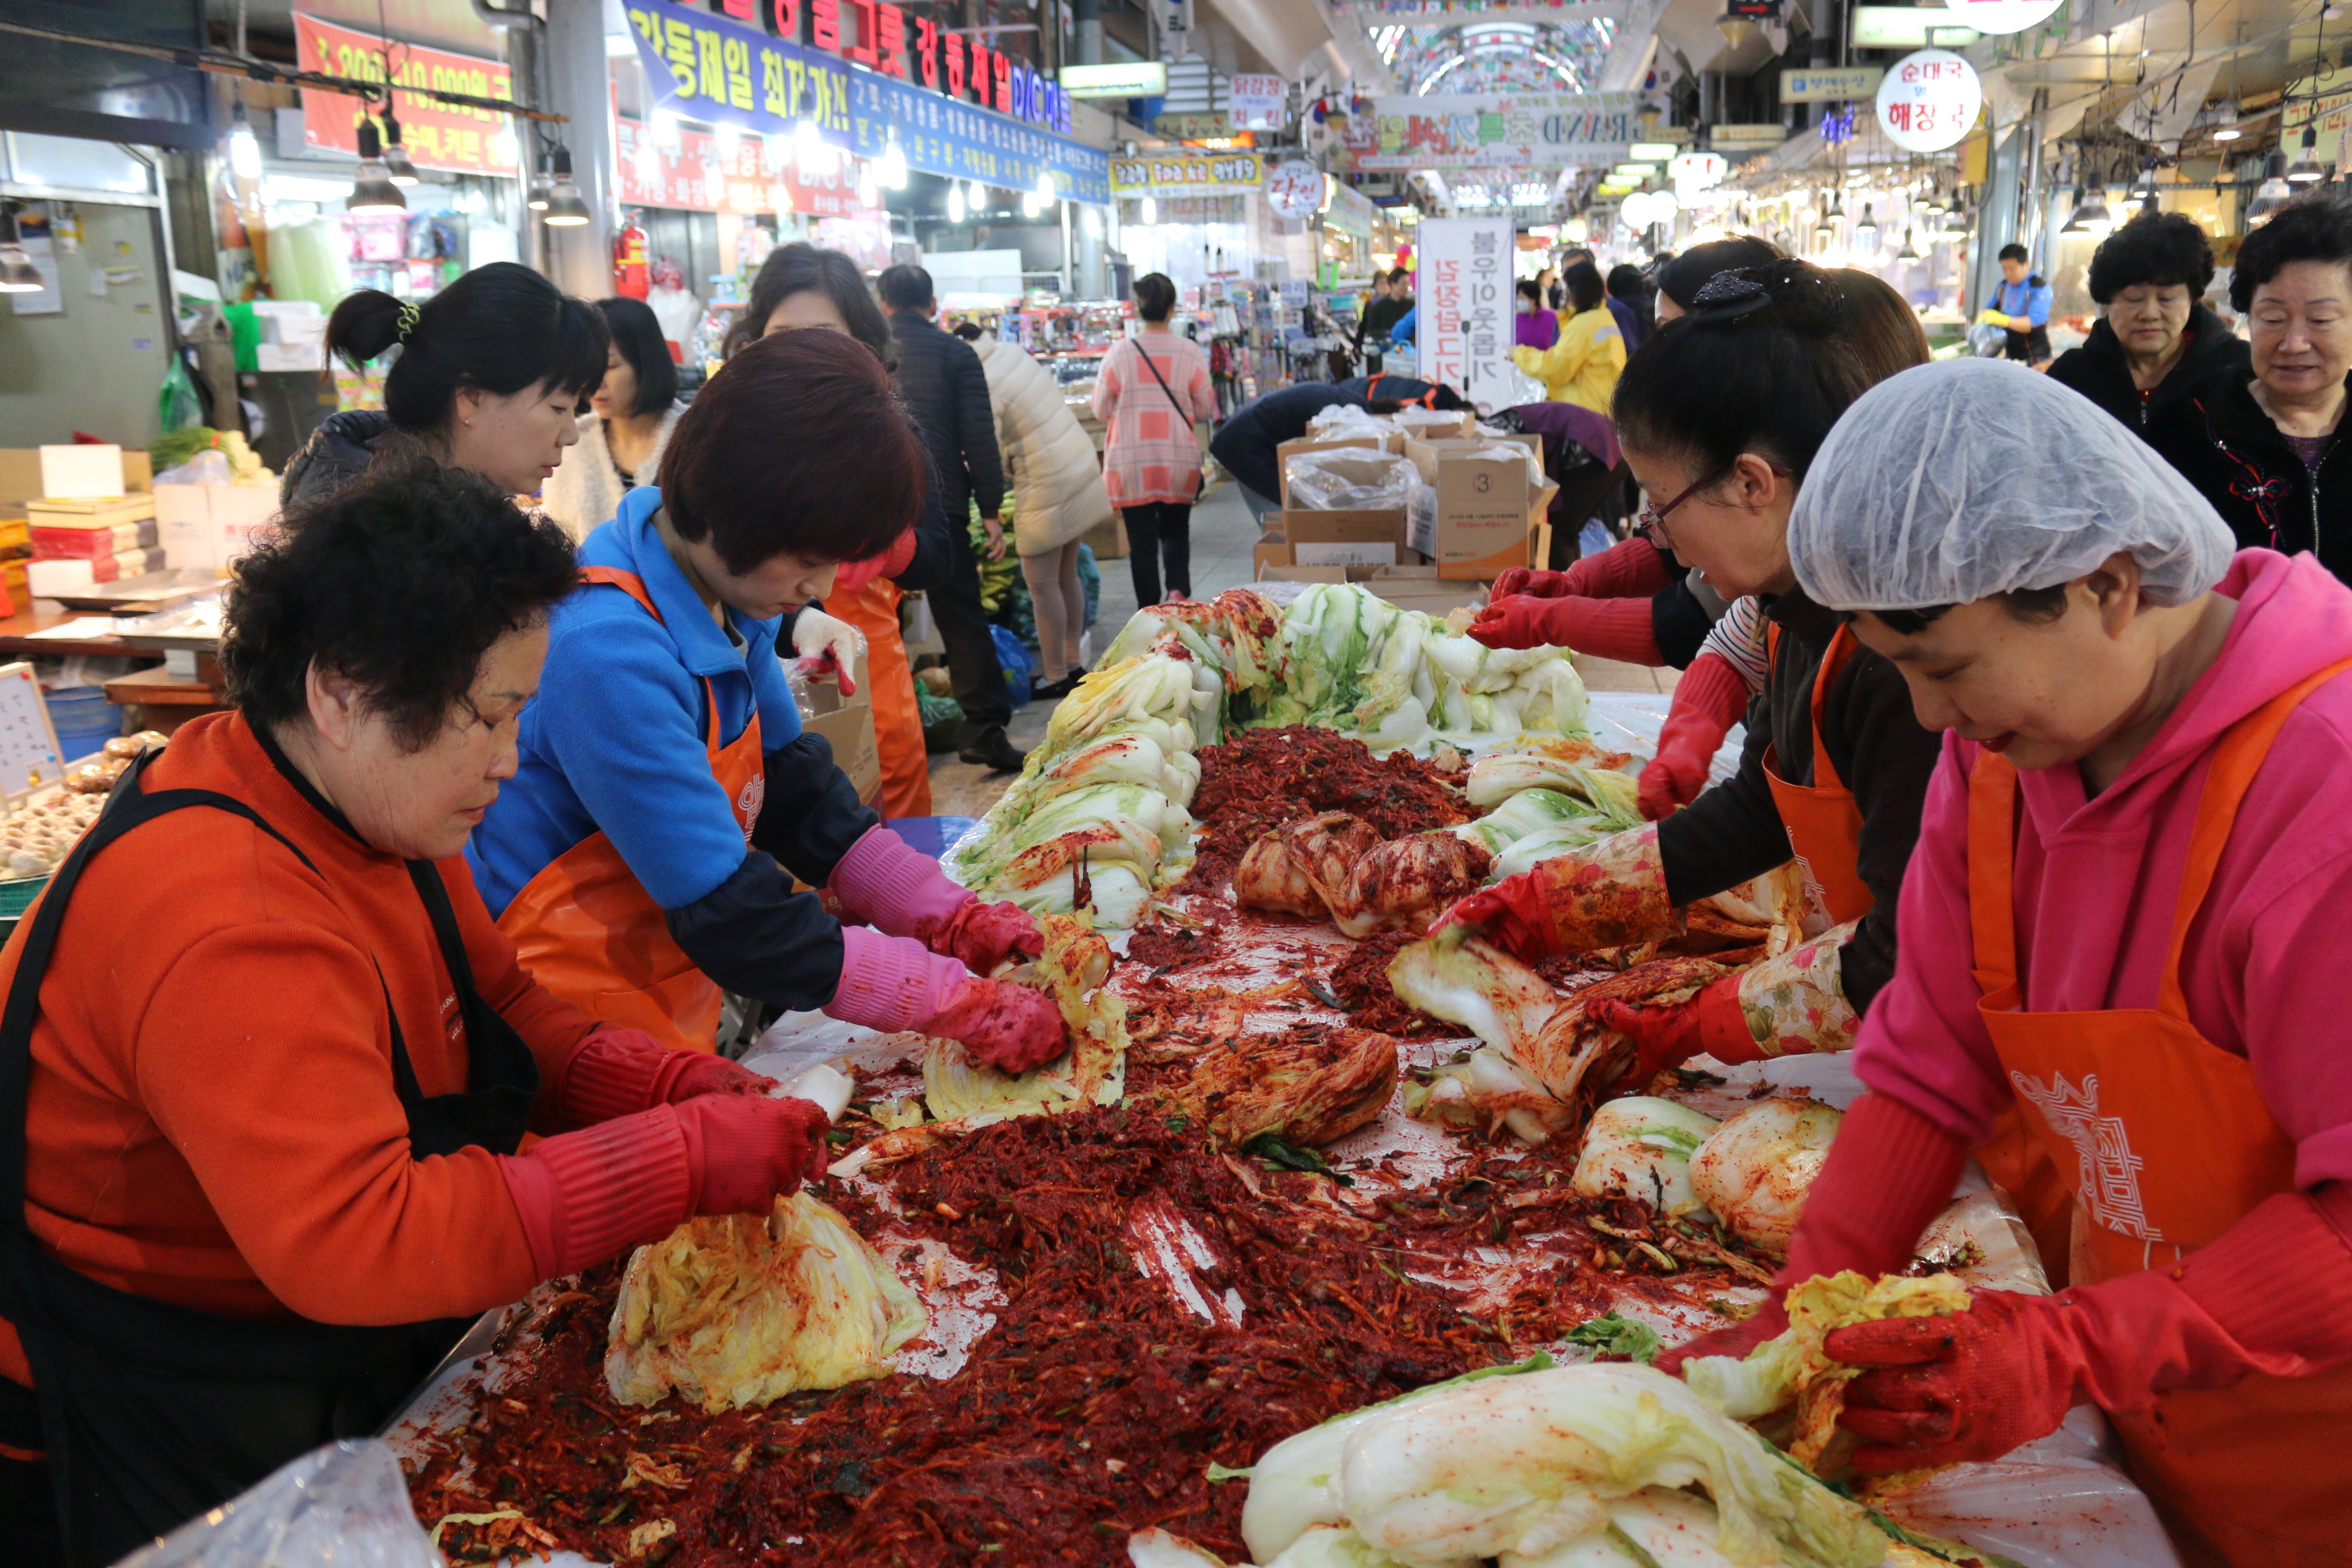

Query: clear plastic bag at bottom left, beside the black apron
left=115, top=1439, right=442, bottom=1568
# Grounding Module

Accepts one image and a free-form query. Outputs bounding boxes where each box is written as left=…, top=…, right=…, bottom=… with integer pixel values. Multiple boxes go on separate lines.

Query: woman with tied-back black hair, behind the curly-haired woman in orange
left=278, top=261, right=607, bottom=505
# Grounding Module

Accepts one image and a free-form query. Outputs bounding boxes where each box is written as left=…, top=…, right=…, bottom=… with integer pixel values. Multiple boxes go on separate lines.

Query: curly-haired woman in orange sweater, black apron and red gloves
left=0, top=468, right=825, bottom=1568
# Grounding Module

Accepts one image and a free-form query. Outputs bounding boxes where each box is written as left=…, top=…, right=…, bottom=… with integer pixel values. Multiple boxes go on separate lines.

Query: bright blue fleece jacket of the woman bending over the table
left=466, top=484, right=809, bottom=915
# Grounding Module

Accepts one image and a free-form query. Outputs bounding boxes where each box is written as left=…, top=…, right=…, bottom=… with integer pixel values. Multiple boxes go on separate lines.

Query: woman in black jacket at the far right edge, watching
left=2147, top=195, right=2352, bottom=580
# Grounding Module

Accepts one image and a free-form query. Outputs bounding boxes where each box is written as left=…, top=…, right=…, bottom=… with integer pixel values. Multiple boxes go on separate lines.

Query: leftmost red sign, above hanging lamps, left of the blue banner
left=294, top=12, right=520, bottom=174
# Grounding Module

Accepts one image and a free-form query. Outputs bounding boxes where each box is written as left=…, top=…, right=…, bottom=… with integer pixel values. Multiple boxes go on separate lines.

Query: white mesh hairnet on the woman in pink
left=1787, top=359, right=2237, bottom=609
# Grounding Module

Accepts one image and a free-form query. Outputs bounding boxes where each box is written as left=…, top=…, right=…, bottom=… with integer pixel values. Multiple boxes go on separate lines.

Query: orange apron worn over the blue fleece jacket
left=499, top=567, right=767, bottom=1050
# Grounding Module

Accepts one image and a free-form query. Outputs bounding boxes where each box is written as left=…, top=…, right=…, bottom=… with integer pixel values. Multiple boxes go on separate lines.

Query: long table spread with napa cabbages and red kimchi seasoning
left=357, top=583, right=2173, bottom=1568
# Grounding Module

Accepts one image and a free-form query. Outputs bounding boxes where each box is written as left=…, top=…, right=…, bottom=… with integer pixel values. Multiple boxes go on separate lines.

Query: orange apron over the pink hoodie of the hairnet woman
left=1969, top=660, right=2352, bottom=1568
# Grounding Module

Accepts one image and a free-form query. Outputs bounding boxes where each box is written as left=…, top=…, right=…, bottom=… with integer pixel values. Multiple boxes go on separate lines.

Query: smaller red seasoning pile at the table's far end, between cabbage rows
left=1176, top=724, right=1473, bottom=893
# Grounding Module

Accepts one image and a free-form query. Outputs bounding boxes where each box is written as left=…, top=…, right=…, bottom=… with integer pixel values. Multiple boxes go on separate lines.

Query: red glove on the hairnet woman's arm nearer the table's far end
left=1656, top=1093, right=1969, bottom=1377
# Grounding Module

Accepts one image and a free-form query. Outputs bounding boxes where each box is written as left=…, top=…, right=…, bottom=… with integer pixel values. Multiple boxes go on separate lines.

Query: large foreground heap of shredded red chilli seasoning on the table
left=412, top=1110, right=1761, bottom=1568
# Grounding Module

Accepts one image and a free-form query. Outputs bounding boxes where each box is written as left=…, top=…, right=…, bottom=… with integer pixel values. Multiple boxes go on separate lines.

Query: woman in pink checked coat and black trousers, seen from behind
left=1093, top=273, right=1216, bottom=604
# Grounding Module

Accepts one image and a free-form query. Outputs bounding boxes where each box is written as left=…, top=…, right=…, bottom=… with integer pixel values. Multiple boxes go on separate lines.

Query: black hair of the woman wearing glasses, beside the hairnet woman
left=1611, top=259, right=1875, bottom=480
